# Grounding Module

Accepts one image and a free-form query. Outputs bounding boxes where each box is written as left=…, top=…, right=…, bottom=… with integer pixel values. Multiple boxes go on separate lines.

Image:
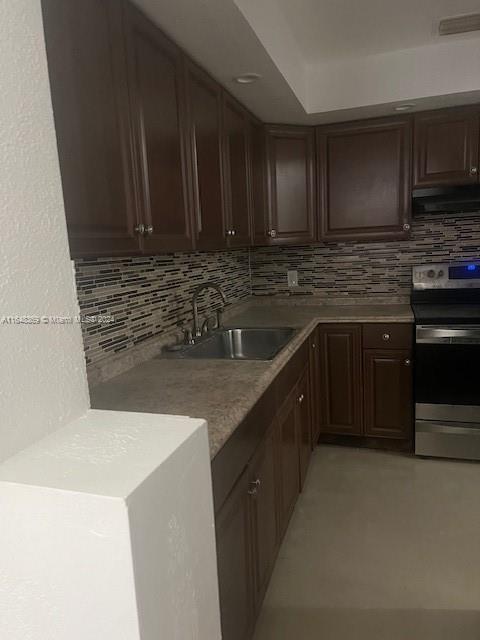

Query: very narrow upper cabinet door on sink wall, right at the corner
left=250, top=121, right=271, bottom=245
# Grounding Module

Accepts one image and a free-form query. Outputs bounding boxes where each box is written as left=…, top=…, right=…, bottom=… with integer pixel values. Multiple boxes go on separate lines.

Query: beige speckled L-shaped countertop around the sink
left=90, top=300, right=413, bottom=458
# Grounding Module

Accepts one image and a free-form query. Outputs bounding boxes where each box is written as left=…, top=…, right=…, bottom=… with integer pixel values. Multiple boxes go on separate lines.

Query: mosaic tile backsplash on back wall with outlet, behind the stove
left=251, top=213, right=480, bottom=297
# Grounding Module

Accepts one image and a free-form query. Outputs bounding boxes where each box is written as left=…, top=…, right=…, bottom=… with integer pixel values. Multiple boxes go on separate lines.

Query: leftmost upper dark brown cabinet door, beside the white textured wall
left=42, top=0, right=140, bottom=257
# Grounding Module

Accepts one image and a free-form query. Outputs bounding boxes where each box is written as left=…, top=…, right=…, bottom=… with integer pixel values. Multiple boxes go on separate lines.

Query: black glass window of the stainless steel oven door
left=415, top=344, right=480, bottom=406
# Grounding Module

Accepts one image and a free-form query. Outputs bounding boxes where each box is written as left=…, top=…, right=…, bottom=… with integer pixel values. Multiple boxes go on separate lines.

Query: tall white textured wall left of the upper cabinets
left=0, top=0, right=88, bottom=460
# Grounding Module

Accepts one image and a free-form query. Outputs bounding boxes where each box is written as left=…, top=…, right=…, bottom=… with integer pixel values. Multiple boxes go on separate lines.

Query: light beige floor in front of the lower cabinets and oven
left=254, top=447, right=480, bottom=640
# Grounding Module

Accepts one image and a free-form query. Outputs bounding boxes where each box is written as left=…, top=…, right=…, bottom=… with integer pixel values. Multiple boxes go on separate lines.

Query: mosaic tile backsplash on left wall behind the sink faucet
left=75, top=249, right=251, bottom=365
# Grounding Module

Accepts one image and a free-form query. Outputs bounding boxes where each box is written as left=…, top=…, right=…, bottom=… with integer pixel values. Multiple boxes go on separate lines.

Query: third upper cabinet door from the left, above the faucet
left=187, top=62, right=227, bottom=249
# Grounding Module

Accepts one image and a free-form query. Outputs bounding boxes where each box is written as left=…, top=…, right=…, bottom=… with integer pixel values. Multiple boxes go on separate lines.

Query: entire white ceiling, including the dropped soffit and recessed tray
left=134, top=0, right=480, bottom=124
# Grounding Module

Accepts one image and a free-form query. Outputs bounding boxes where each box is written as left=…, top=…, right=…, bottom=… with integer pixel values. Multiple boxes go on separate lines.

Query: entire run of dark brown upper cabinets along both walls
left=42, top=0, right=480, bottom=257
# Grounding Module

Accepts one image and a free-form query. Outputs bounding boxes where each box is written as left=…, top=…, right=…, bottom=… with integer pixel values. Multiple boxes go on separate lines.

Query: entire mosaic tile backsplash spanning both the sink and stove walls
left=75, top=214, right=480, bottom=365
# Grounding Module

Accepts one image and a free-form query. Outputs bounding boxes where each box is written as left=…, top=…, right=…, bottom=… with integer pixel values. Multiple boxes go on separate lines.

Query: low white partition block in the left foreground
left=0, top=411, right=221, bottom=640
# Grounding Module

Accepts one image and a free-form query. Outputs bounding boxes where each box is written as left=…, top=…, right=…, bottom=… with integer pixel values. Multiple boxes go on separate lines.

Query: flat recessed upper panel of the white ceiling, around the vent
left=274, top=0, right=480, bottom=63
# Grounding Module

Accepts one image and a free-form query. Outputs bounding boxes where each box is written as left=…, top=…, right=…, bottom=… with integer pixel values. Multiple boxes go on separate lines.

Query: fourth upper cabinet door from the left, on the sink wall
left=223, top=95, right=251, bottom=247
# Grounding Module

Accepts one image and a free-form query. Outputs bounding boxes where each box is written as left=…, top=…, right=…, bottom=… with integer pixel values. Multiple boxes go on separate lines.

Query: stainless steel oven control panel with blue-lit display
left=412, top=261, right=480, bottom=289
